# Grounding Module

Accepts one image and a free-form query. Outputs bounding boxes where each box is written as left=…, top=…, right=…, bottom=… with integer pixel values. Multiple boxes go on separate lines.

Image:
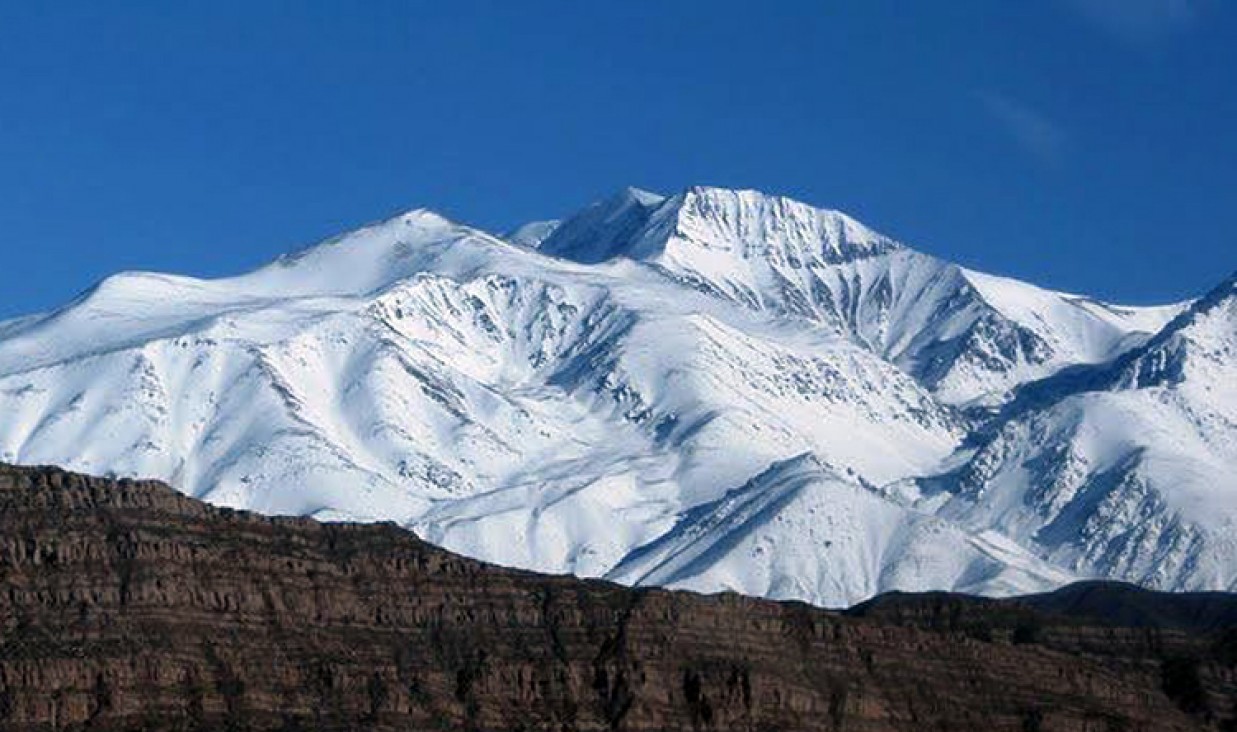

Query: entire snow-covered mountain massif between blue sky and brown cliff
left=0, top=188, right=1217, bottom=605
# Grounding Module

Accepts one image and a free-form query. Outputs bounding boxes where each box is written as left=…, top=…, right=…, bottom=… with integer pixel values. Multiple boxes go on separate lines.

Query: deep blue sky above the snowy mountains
left=0, top=0, right=1237, bottom=317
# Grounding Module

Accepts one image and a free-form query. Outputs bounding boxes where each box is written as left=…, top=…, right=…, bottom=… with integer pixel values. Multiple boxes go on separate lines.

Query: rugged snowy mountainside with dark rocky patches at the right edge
left=922, top=276, right=1237, bottom=590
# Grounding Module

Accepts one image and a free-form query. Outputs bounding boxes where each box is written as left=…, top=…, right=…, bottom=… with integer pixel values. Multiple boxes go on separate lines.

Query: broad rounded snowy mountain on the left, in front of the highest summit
left=0, top=191, right=962, bottom=602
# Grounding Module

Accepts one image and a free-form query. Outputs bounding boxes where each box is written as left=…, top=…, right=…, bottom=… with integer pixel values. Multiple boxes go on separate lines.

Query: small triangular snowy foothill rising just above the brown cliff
left=606, top=455, right=1071, bottom=600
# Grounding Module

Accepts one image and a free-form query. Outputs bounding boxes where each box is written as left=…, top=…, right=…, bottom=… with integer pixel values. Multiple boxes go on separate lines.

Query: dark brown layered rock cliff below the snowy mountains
left=0, top=466, right=1237, bottom=731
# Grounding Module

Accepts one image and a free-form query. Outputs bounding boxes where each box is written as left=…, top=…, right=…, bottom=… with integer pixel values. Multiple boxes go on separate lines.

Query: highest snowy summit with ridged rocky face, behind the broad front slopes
left=542, top=188, right=1179, bottom=404
